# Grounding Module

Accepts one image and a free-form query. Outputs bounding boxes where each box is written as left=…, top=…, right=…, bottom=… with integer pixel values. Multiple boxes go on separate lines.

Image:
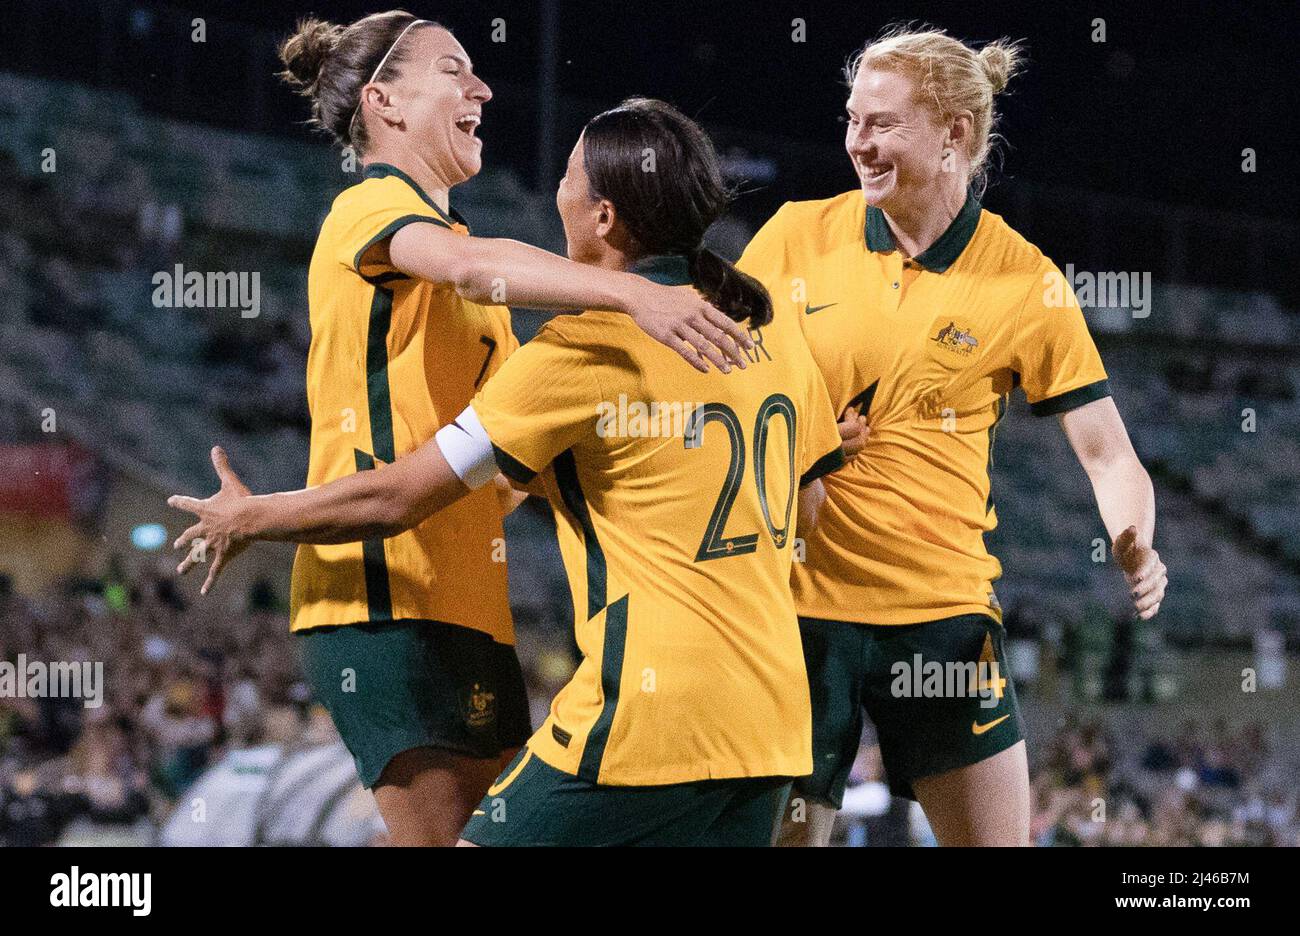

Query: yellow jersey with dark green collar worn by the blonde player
left=740, top=191, right=1109, bottom=624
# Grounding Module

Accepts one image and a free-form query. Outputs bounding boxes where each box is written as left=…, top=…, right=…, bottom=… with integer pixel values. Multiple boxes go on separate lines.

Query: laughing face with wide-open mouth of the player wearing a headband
left=363, top=26, right=491, bottom=189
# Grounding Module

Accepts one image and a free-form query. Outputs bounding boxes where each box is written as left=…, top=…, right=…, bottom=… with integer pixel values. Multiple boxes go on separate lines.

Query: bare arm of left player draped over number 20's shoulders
left=374, top=224, right=754, bottom=373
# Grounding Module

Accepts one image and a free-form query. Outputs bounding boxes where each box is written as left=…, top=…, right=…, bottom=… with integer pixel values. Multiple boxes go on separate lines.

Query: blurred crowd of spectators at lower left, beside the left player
left=0, top=564, right=306, bottom=845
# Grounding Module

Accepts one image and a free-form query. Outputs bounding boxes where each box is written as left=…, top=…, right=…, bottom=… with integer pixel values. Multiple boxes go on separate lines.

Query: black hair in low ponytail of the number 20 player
left=582, top=98, right=772, bottom=328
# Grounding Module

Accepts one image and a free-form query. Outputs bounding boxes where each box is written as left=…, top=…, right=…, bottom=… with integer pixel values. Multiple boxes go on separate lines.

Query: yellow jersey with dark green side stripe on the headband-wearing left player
left=290, top=165, right=519, bottom=644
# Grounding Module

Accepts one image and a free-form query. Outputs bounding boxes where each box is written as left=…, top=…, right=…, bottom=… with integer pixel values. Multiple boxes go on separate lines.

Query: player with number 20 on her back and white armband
left=169, top=100, right=842, bottom=845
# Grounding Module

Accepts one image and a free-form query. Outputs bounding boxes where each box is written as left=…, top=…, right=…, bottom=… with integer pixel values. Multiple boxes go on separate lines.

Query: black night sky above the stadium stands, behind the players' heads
left=0, top=0, right=1300, bottom=306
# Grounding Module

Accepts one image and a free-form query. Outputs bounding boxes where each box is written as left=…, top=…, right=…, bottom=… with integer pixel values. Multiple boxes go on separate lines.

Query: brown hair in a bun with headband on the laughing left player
left=278, top=10, right=438, bottom=155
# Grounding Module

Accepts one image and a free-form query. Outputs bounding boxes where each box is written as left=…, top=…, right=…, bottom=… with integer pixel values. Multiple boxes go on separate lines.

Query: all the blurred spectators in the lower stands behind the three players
left=0, top=563, right=1300, bottom=845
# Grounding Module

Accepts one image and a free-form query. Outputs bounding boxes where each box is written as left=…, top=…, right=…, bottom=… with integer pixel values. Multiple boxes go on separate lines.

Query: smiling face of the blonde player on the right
left=844, top=68, right=961, bottom=215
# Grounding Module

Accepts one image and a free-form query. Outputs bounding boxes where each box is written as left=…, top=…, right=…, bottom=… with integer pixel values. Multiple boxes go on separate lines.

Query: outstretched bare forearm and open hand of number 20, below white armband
left=168, top=439, right=469, bottom=594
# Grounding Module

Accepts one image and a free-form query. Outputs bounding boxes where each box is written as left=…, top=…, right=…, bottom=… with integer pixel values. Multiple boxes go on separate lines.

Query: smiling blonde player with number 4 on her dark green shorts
left=738, top=29, right=1166, bottom=845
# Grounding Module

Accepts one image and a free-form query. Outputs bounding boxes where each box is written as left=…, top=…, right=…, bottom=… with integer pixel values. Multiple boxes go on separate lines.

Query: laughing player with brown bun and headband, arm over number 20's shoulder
left=265, top=10, right=749, bottom=844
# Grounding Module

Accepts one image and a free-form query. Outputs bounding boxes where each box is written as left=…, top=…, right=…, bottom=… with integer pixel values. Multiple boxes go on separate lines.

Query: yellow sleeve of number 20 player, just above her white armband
left=472, top=322, right=601, bottom=484
